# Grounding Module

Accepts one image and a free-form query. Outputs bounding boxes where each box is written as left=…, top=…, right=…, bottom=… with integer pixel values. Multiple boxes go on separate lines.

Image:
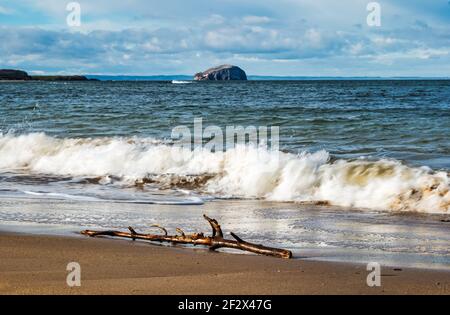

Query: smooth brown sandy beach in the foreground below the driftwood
left=0, top=233, right=450, bottom=295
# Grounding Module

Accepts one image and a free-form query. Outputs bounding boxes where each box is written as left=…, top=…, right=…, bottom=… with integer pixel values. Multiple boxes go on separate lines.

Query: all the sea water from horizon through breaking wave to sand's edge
left=0, top=80, right=450, bottom=265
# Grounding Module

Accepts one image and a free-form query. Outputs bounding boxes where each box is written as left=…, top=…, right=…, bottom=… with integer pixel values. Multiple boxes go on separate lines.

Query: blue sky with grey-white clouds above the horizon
left=0, top=0, right=450, bottom=77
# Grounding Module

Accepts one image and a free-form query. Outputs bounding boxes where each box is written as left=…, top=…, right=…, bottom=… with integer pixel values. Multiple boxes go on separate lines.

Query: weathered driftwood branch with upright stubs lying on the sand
left=81, top=215, right=292, bottom=258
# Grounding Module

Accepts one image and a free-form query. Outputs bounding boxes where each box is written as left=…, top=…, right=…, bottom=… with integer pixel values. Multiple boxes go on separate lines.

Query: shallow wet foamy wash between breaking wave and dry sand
left=0, top=198, right=450, bottom=271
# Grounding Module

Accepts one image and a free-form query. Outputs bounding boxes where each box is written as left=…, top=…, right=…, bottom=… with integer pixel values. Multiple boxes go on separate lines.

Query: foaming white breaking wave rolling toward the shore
left=0, top=133, right=450, bottom=213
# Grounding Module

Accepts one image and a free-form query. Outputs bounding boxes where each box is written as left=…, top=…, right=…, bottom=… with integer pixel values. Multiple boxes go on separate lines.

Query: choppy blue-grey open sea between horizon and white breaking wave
left=0, top=80, right=450, bottom=170
